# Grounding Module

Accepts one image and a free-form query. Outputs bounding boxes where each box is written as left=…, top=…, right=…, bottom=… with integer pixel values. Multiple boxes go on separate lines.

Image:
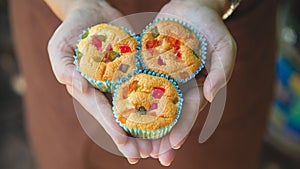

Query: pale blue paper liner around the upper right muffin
left=137, top=18, right=207, bottom=83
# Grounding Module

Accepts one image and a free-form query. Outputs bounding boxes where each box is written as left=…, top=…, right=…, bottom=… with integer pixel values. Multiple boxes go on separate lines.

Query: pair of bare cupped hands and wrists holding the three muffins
left=45, top=0, right=236, bottom=166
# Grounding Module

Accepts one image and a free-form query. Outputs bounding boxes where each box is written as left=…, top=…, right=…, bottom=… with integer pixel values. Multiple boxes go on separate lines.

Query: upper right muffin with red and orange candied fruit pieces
left=140, top=19, right=206, bottom=82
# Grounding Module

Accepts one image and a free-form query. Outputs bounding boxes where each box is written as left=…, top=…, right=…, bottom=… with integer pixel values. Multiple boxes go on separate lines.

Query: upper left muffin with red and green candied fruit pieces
left=75, top=24, right=138, bottom=92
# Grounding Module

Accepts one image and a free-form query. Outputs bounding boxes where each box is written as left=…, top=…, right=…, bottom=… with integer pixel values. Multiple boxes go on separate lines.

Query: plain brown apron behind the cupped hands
left=10, top=0, right=276, bottom=169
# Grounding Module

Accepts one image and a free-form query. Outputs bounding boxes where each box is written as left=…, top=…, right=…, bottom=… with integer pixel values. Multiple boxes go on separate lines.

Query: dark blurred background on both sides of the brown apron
left=0, top=0, right=300, bottom=169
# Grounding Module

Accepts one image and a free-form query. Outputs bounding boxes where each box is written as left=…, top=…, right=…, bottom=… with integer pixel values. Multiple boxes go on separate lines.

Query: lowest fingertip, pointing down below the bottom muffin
left=158, top=136, right=175, bottom=166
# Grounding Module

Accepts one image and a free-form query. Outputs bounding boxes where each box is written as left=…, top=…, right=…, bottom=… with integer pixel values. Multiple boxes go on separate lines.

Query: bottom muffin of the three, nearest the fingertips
left=113, top=71, right=183, bottom=139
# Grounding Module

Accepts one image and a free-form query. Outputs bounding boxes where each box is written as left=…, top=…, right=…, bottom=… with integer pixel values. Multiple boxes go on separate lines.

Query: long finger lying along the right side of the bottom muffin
left=169, top=86, right=207, bottom=149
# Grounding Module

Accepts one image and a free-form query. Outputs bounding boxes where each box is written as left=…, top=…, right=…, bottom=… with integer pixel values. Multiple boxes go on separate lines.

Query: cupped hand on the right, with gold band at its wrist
left=151, top=0, right=237, bottom=165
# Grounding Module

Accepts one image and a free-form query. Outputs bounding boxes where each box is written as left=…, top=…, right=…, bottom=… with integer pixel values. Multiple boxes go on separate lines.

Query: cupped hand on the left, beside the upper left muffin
left=48, top=0, right=152, bottom=163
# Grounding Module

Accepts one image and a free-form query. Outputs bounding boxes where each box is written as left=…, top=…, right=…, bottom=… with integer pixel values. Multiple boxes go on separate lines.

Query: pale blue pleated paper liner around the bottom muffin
left=112, top=69, right=183, bottom=139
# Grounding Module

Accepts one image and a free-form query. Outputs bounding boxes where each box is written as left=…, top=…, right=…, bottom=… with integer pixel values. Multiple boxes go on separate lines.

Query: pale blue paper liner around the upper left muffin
left=73, top=25, right=141, bottom=92
